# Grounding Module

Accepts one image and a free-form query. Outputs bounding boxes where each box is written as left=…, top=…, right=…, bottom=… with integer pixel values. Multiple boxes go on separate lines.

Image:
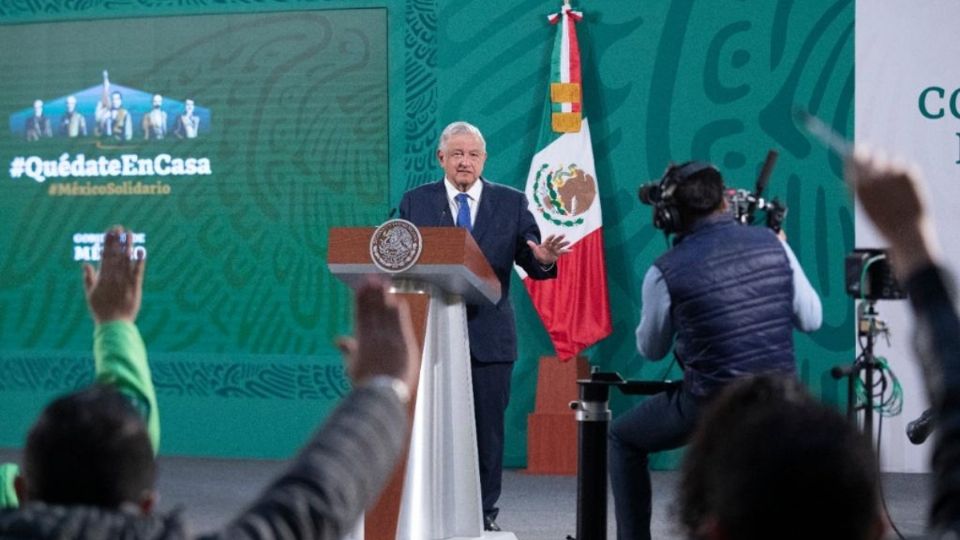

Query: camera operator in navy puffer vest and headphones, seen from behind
left=609, top=162, right=822, bottom=539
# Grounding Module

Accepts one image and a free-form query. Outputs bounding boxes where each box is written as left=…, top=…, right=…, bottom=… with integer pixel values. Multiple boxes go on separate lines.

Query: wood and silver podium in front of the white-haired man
left=327, top=222, right=515, bottom=540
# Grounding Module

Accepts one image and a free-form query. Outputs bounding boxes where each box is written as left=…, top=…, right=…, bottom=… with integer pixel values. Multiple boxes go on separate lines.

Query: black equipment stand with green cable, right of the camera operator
left=830, top=299, right=889, bottom=440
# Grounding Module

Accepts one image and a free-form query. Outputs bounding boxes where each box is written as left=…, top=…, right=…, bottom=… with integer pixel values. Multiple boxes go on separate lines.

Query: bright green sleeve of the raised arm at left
left=93, top=321, right=160, bottom=454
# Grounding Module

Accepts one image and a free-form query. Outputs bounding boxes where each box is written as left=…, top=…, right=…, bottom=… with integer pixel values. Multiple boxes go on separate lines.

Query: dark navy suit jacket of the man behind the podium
left=400, top=178, right=557, bottom=363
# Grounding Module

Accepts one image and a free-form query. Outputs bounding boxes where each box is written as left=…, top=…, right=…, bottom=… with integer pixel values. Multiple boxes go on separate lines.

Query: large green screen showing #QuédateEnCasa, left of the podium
left=0, top=9, right=388, bottom=456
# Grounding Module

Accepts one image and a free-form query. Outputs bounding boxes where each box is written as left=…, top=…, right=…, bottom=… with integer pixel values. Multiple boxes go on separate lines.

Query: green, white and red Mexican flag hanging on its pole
left=517, top=3, right=611, bottom=360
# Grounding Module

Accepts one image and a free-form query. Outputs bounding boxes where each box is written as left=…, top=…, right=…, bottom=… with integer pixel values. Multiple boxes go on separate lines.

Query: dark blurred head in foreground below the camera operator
left=679, top=376, right=886, bottom=540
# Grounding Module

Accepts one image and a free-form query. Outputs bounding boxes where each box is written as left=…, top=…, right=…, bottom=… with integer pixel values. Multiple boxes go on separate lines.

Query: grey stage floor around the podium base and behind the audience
left=0, top=449, right=932, bottom=540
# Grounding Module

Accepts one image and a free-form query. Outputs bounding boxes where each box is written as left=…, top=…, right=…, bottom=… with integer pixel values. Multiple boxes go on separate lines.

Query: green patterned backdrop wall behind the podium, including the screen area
left=0, top=0, right=854, bottom=467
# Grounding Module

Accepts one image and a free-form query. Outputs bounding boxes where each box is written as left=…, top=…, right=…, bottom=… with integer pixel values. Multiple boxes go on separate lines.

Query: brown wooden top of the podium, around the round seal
left=327, top=227, right=501, bottom=304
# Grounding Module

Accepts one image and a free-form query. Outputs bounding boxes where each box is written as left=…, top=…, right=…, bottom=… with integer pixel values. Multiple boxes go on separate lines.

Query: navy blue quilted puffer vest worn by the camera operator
left=654, top=215, right=796, bottom=396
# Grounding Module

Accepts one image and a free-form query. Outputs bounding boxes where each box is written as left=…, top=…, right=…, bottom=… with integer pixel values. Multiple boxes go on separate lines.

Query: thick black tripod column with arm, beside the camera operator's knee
left=567, top=368, right=680, bottom=540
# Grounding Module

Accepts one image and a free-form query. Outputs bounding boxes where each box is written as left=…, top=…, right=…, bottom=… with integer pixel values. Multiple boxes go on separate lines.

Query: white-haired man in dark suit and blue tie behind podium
left=400, top=122, right=569, bottom=531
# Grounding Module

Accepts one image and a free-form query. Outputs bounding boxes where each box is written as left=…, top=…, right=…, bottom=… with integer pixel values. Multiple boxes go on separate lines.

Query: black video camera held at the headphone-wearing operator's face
left=637, top=150, right=787, bottom=234
